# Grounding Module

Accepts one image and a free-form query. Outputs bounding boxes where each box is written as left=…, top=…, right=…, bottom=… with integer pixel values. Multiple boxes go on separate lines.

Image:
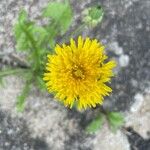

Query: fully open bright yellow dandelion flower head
left=43, top=36, right=116, bottom=109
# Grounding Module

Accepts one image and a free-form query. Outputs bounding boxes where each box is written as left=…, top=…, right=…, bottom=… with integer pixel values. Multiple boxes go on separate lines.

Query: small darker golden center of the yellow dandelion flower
left=72, top=66, right=85, bottom=79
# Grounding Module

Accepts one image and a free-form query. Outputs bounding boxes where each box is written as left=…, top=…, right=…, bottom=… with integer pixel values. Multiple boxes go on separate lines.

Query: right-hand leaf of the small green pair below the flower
left=107, top=112, right=124, bottom=132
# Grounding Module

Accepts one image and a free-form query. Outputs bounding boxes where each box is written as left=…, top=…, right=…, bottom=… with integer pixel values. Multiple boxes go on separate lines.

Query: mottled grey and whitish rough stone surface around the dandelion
left=0, top=0, right=150, bottom=150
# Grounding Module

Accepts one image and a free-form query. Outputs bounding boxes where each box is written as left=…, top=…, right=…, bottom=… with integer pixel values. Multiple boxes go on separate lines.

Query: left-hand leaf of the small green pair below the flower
left=86, top=114, right=104, bottom=133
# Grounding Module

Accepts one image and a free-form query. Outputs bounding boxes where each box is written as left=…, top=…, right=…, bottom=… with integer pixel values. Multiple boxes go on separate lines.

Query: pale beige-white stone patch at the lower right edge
left=126, top=94, right=150, bottom=139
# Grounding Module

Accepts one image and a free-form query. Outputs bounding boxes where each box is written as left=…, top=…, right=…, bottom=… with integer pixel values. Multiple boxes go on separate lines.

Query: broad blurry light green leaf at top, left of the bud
left=43, top=2, right=72, bottom=34
